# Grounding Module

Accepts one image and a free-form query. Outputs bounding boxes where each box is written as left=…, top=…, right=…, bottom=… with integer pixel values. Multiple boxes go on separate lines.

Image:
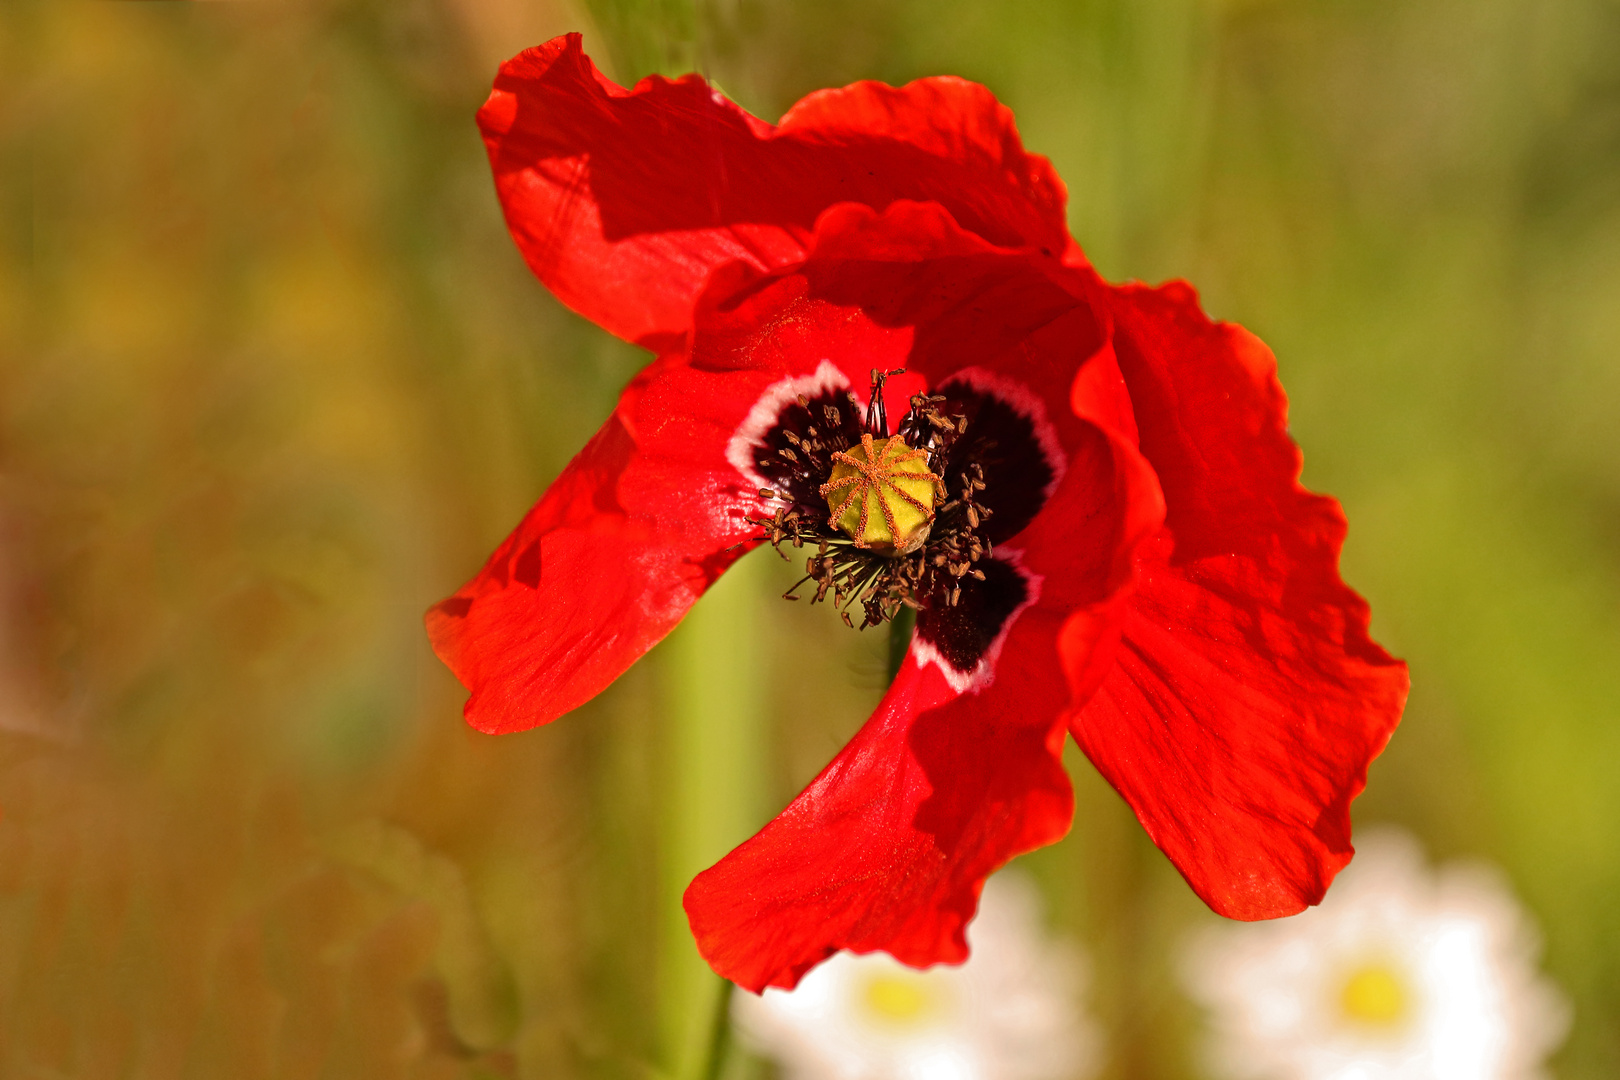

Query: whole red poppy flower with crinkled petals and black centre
left=428, top=36, right=1406, bottom=989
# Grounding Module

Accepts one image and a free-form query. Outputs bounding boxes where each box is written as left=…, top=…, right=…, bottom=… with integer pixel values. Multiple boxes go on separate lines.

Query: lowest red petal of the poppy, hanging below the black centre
left=685, top=634, right=1074, bottom=993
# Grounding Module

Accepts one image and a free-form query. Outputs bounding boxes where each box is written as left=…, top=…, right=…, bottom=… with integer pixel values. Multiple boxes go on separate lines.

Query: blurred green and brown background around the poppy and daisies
left=0, top=0, right=1620, bottom=1080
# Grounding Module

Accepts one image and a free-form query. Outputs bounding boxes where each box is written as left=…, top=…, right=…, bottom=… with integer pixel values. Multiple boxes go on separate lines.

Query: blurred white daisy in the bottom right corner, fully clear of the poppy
left=1184, top=832, right=1570, bottom=1080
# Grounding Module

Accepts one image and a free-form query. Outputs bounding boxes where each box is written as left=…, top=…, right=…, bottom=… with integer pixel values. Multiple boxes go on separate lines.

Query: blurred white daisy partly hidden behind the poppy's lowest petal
left=732, top=873, right=1100, bottom=1080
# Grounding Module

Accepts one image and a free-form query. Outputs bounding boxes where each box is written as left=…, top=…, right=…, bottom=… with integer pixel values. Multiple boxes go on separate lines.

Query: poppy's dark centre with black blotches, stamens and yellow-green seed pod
left=741, top=361, right=1063, bottom=685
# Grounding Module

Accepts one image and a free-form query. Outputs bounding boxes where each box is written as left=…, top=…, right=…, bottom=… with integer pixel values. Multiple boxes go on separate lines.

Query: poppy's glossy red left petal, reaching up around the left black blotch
left=428, top=255, right=910, bottom=732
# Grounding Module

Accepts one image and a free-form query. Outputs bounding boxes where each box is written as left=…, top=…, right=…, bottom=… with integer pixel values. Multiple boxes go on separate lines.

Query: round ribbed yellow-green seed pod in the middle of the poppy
left=820, top=434, right=944, bottom=554
